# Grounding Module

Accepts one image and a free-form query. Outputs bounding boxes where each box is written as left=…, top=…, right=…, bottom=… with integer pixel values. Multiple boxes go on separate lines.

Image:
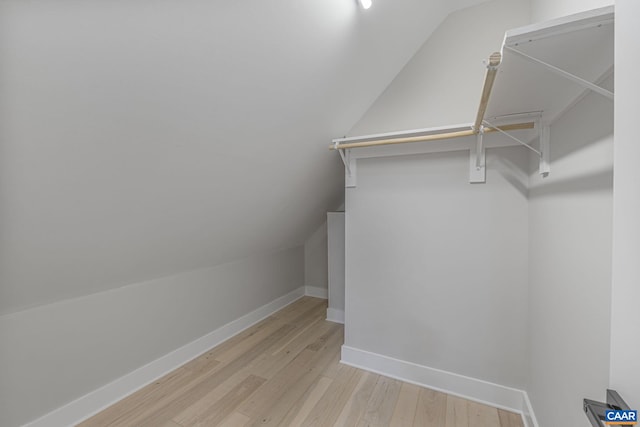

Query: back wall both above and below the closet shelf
left=345, top=0, right=530, bottom=388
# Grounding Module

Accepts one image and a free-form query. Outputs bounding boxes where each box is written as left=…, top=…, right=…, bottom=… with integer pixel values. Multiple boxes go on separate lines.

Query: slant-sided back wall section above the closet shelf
left=349, top=0, right=529, bottom=135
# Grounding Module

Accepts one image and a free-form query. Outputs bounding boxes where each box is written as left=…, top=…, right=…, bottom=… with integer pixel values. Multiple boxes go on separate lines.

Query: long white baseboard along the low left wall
left=24, top=286, right=305, bottom=427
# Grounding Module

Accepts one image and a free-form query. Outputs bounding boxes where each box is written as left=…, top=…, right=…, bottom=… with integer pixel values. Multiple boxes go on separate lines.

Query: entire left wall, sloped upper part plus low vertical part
left=0, top=0, right=484, bottom=426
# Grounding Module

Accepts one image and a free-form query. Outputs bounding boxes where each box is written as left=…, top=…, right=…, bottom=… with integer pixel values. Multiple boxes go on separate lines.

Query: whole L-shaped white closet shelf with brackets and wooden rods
left=331, top=6, right=615, bottom=187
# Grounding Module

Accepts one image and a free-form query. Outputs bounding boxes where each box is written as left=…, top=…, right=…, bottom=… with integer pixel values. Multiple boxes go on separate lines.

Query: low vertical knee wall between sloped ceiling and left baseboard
left=0, top=247, right=304, bottom=427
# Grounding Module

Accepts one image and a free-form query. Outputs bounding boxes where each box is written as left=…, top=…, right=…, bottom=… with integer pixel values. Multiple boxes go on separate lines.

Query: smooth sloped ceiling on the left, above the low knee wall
left=0, top=0, right=480, bottom=313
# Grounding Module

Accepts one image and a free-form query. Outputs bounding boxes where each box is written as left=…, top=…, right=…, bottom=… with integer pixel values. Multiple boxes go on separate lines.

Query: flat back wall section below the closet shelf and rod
left=345, top=147, right=528, bottom=389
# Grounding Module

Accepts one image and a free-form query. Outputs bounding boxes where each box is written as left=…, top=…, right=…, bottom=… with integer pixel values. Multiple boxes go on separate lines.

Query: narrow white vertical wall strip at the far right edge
left=611, top=0, right=640, bottom=409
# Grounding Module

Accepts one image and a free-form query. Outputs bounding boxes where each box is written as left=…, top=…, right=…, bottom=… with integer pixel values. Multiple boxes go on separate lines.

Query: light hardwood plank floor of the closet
left=80, top=297, right=522, bottom=427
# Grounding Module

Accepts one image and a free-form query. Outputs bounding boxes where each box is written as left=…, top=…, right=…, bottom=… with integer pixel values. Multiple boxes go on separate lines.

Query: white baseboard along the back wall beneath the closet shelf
left=341, top=345, right=538, bottom=427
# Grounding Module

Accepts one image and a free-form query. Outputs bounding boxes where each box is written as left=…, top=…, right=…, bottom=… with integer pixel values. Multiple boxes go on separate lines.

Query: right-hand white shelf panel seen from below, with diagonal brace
left=485, top=6, right=614, bottom=123
